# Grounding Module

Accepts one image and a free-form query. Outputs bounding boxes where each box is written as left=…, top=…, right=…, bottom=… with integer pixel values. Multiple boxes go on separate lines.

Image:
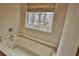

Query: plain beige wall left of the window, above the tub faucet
left=0, top=4, right=20, bottom=35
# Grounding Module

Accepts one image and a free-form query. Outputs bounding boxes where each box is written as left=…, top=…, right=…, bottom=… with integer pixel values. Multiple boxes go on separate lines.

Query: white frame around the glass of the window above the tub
left=25, top=11, right=54, bottom=33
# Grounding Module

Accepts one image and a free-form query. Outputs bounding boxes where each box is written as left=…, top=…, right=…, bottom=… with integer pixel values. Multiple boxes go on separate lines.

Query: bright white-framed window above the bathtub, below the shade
left=25, top=11, right=54, bottom=33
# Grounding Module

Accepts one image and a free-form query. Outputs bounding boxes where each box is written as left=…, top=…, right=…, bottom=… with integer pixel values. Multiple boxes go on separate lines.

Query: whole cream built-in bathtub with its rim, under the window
left=0, top=34, right=56, bottom=56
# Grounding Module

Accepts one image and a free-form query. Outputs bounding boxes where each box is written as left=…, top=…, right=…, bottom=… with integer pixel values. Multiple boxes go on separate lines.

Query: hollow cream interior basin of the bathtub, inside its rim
left=16, top=37, right=56, bottom=56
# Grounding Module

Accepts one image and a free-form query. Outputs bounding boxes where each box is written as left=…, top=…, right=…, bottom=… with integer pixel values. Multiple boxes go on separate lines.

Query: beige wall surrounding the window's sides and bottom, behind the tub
left=21, top=4, right=67, bottom=44
